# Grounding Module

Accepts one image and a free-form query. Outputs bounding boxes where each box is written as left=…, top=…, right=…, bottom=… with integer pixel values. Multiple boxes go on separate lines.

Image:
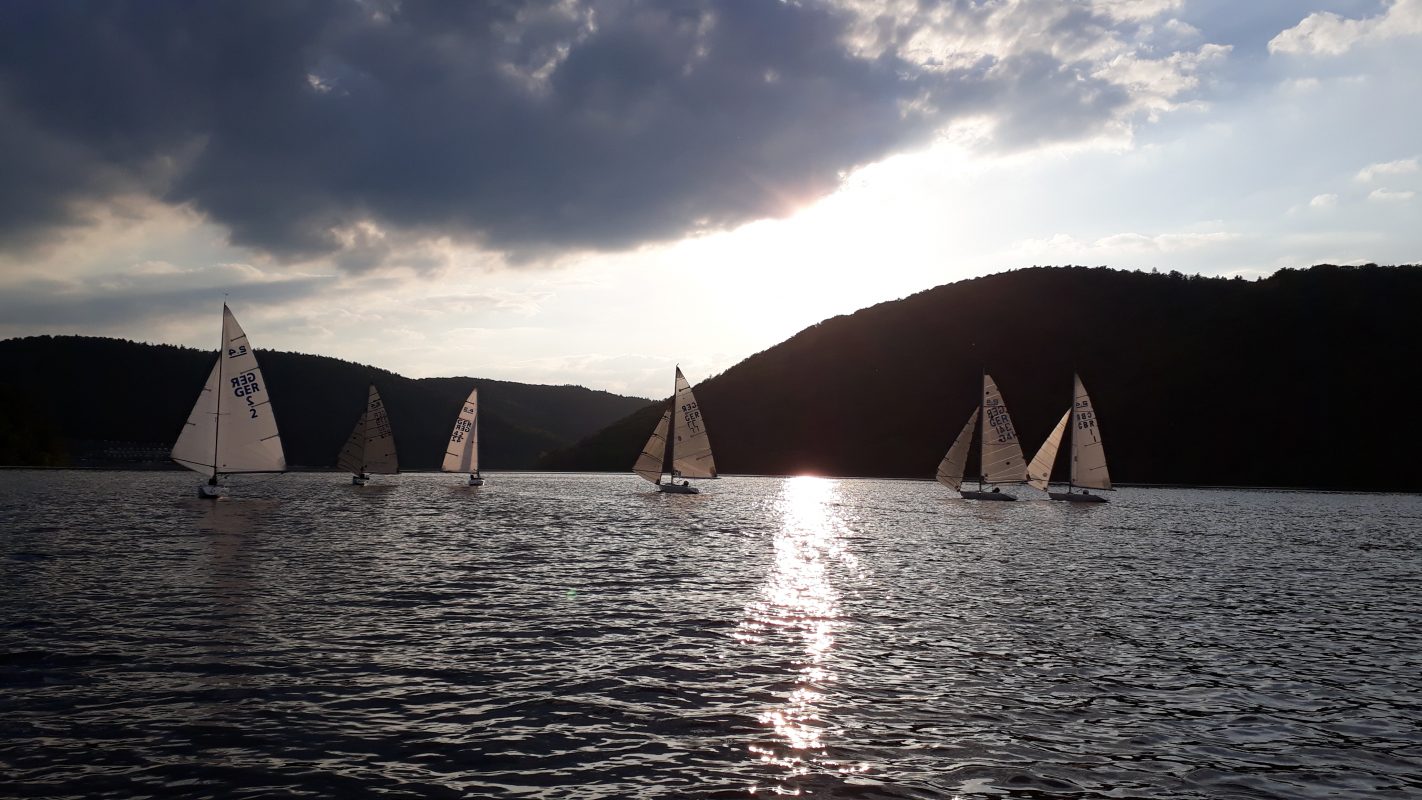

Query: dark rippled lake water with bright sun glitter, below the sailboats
left=0, top=472, right=1422, bottom=799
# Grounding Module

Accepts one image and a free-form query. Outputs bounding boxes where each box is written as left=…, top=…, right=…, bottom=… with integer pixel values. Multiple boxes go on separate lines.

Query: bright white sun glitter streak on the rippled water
left=737, top=477, right=867, bottom=794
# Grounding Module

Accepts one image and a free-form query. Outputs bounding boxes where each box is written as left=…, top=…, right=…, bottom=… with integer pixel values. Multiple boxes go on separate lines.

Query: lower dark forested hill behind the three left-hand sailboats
left=0, top=337, right=647, bottom=469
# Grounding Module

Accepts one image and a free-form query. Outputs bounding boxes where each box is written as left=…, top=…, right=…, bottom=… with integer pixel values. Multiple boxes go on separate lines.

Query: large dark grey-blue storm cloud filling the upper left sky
left=0, top=0, right=1166, bottom=264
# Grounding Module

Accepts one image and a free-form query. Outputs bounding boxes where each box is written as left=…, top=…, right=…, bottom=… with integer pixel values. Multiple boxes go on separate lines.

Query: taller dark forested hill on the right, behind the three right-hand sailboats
left=542, top=266, right=1422, bottom=492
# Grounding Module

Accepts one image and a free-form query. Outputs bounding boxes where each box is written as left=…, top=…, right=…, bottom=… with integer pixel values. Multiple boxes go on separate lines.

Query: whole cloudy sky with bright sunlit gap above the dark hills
left=0, top=0, right=1422, bottom=396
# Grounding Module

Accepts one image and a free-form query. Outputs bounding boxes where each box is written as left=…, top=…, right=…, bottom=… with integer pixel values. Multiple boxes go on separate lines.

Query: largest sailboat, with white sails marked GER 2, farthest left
left=172, top=303, right=286, bottom=500
